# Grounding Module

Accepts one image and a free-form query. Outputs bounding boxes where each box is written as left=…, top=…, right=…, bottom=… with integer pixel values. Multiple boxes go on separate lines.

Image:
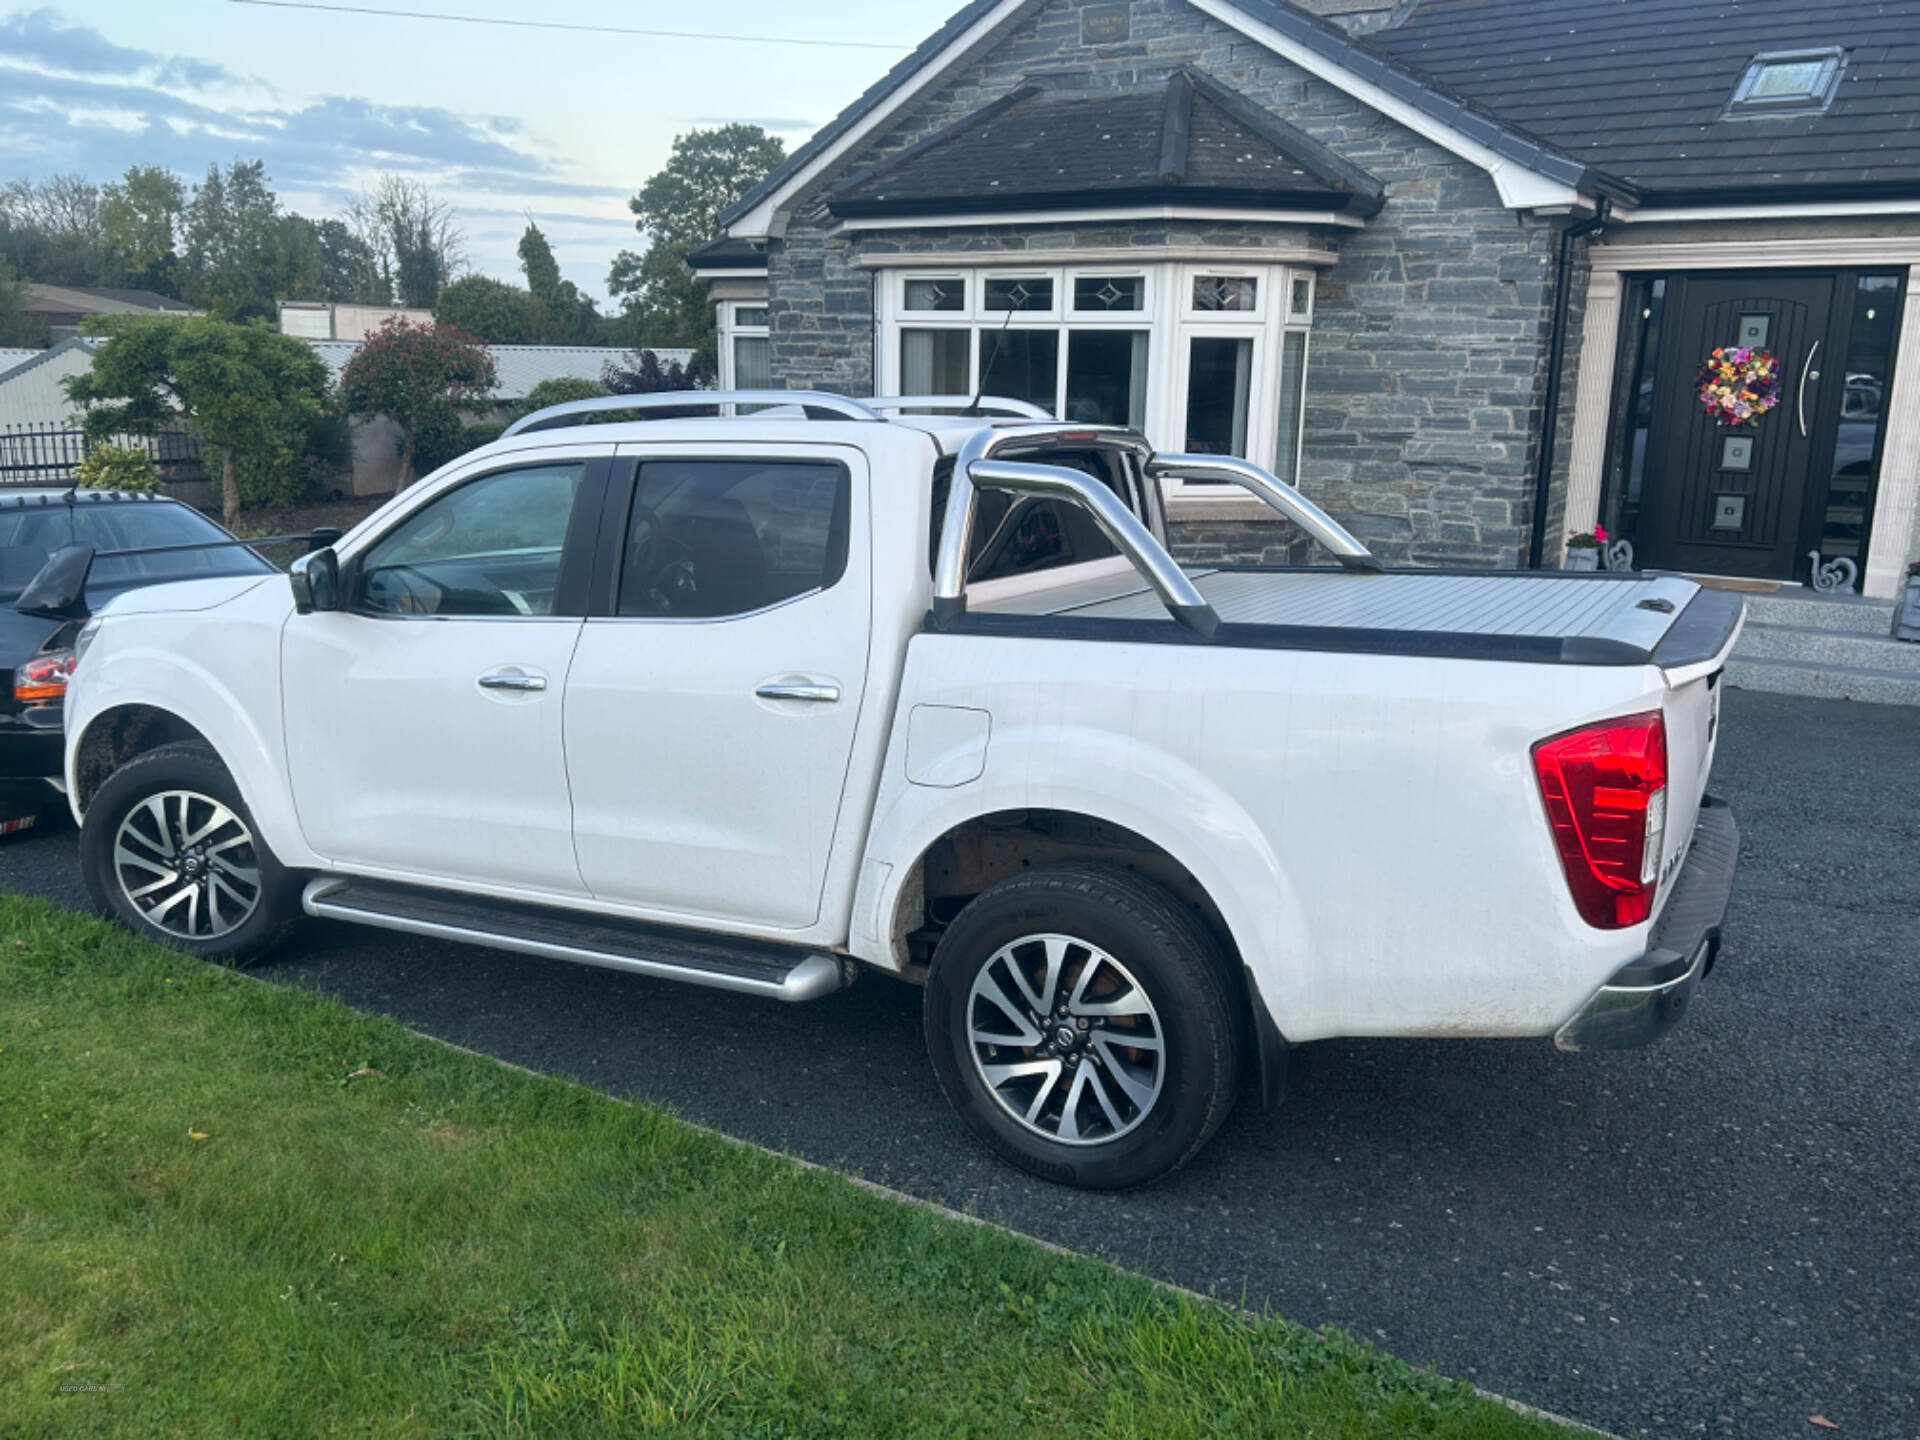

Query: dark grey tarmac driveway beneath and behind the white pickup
left=0, top=691, right=1920, bottom=1440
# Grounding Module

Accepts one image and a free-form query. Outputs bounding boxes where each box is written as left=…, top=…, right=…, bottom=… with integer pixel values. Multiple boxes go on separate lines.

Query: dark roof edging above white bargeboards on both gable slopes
left=720, top=0, right=1640, bottom=237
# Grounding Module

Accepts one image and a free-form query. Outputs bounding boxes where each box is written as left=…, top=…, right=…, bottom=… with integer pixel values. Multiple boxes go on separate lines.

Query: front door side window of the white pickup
left=357, top=465, right=586, bottom=614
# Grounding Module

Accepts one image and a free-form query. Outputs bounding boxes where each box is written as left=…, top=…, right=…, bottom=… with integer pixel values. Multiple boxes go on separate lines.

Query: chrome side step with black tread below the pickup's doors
left=300, top=876, right=851, bottom=1000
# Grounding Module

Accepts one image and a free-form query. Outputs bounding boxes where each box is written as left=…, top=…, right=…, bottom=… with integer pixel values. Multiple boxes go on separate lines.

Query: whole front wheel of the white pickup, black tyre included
left=81, top=745, right=300, bottom=962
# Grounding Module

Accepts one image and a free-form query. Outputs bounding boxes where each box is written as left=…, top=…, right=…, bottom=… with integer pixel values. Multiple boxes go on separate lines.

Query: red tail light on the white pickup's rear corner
left=1534, top=710, right=1667, bottom=929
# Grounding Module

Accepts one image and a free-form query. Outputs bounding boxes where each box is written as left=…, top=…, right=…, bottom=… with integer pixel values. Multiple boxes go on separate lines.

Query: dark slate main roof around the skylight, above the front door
left=1367, top=0, right=1920, bottom=204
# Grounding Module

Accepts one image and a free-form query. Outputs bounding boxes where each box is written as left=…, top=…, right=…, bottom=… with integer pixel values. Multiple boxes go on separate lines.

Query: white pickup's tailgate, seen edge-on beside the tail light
left=1653, top=589, right=1747, bottom=906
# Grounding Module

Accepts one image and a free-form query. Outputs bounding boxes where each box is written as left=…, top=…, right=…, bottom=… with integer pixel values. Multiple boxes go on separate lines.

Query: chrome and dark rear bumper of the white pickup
left=1553, top=797, right=1740, bottom=1050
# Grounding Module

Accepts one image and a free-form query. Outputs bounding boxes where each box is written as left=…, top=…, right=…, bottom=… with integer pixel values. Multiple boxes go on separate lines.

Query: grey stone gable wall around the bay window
left=768, top=0, right=1578, bottom=564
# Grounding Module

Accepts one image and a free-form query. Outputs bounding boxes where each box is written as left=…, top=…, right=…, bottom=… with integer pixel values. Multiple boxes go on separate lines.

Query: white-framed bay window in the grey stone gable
left=876, top=255, right=1313, bottom=499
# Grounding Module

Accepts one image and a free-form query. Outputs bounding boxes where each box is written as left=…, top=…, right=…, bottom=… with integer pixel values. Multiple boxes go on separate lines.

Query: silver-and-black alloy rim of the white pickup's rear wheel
left=966, top=935, right=1167, bottom=1144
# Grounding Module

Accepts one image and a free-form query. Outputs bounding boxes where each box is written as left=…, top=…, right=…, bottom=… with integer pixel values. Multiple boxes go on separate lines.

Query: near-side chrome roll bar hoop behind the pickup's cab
left=933, top=422, right=1219, bottom=639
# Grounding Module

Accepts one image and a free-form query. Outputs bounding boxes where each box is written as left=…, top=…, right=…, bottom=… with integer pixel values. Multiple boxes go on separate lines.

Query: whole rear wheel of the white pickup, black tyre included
left=925, top=864, right=1242, bottom=1190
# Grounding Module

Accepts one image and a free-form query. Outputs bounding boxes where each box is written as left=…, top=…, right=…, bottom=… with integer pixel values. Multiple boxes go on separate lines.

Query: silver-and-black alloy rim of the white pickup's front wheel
left=113, top=789, right=261, bottom=941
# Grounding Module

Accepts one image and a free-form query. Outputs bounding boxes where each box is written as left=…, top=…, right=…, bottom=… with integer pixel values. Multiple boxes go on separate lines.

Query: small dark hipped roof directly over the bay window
left=828, top=71, right=1384, bottom=217
